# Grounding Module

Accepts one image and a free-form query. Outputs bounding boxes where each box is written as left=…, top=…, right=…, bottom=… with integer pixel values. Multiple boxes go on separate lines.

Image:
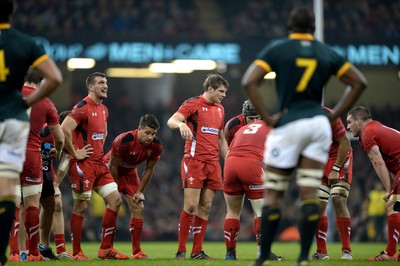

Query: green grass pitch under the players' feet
left=8, top=242, right=395, bottom=266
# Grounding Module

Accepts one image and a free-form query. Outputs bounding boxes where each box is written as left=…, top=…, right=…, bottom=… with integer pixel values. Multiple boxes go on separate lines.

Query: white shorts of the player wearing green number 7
left=264, top=115, right=332, bottom=169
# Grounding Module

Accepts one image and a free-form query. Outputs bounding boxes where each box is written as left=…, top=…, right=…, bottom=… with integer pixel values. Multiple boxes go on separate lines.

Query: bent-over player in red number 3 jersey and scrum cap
left=224, top=119, right=282, bottom=260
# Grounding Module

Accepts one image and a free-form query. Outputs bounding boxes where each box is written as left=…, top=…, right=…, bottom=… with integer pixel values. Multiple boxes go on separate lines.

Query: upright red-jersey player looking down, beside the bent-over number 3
left=167, top=74, right=229, bottom=260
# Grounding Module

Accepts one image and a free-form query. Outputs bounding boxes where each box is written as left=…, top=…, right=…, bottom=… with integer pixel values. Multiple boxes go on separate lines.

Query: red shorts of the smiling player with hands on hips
left=68, top=159, right=114, bottom=191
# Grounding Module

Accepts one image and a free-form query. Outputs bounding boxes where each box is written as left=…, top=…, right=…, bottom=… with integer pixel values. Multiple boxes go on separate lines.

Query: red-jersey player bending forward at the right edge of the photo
left=347, top=106, right=400, bottom=261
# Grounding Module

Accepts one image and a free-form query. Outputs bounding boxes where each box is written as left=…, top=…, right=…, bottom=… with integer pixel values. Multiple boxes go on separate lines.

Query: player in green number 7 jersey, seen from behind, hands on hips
left=242, top=7, right=367, bottom=265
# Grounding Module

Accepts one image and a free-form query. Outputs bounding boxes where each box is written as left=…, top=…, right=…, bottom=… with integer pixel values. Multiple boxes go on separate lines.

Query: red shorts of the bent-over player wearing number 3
left=224, top=156, right=265, bottom=199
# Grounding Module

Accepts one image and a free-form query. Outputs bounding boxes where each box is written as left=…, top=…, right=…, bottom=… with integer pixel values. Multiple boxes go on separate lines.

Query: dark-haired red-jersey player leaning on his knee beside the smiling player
left=104, top=114, right=162, bottom=259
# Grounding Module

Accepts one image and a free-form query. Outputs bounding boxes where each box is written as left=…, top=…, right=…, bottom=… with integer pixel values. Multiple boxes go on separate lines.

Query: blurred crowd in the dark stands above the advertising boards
left=10, top=0, right=400, bottom=43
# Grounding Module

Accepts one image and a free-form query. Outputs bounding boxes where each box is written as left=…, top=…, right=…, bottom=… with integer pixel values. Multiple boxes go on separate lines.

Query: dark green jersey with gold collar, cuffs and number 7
left=255, top=33, right=351, bottom=126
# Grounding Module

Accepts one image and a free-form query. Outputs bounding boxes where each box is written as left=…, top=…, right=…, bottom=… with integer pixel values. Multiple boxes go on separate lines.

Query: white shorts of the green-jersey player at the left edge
left=0, top=119, right=29, bottom=178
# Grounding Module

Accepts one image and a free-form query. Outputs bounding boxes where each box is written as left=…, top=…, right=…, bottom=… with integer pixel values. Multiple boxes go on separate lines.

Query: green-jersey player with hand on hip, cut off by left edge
left=0, top=0, right=62, bottom=265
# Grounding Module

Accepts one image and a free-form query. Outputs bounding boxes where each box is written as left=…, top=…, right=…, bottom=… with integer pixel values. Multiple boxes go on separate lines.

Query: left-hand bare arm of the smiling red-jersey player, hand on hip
left=61, top=116, right=93, bottom=160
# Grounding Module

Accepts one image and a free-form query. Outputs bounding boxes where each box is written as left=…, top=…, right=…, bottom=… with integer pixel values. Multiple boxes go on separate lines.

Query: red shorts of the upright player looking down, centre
left=181, top=157, right=223, bottom=190
